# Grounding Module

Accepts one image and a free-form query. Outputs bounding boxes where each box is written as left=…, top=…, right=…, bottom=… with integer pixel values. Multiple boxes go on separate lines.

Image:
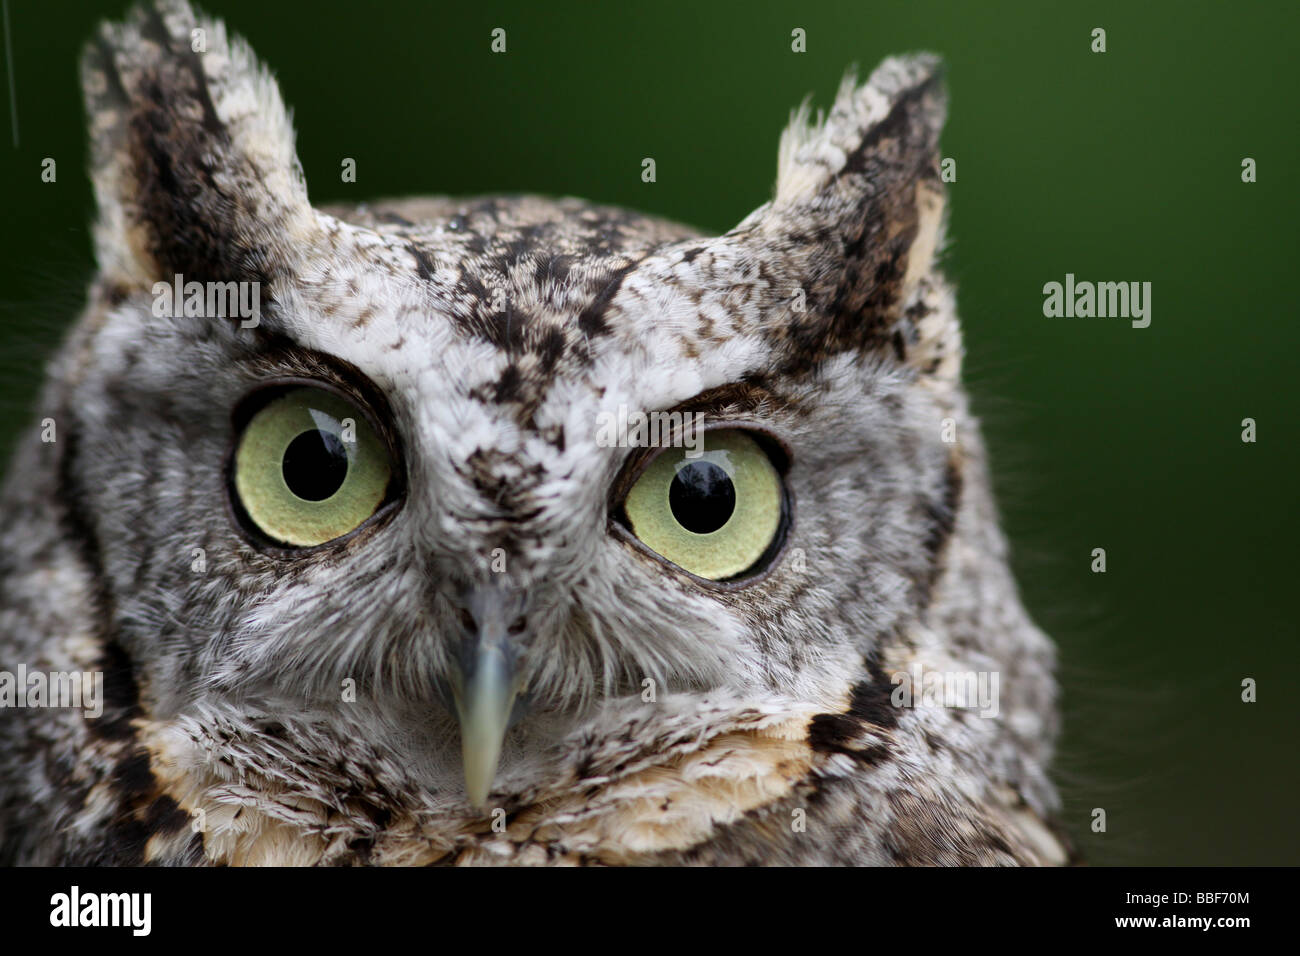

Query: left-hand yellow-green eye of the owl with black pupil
left=233, top=388, right=393, bottom=548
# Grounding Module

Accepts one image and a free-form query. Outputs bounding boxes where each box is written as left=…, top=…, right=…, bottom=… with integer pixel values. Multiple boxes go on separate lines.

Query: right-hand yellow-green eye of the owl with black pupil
left=623, top=429, right=784, bottom=581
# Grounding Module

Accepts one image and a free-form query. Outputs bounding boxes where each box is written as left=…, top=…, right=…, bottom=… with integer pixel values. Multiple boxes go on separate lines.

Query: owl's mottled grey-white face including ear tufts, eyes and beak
left=38, top=3, right=1045, bottom=837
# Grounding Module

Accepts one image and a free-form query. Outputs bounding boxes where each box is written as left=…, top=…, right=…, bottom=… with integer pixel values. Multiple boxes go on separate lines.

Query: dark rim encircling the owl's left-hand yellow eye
left=224, top=376, right=406, bottom=558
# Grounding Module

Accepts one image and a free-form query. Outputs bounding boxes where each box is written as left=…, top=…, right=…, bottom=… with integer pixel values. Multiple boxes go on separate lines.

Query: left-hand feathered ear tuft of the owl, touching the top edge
left=82, top=0, right=315, bottom=287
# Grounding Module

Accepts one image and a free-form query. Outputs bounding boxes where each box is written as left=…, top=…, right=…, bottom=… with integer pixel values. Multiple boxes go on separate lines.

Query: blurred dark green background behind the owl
left=0, top=0, right=1300, bottom=864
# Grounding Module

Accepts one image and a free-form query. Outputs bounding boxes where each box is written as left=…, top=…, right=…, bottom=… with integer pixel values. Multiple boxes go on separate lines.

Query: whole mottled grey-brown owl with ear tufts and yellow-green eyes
left=0, top=0, right=1071, bottom=865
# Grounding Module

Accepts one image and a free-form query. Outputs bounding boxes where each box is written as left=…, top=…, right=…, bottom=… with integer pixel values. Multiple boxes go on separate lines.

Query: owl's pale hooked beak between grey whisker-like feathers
left=452, top=587, right=524, bottom=806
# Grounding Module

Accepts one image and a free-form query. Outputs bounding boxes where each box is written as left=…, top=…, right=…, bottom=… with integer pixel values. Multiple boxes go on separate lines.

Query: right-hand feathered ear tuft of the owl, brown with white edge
left=724, top=53, right=961, bottom=377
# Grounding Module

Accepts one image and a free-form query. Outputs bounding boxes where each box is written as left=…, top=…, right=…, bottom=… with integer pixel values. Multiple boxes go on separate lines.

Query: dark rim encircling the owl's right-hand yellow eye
left=608, top=420, right=794, bottom=592
